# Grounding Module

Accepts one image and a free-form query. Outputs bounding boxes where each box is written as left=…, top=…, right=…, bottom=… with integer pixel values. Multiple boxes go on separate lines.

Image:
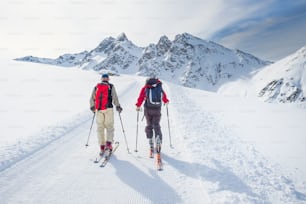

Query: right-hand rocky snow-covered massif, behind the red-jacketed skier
left=138, top=33, right=270, bottom=91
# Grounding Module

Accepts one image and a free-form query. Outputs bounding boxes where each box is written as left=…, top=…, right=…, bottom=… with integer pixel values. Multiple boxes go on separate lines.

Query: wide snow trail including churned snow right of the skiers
left=0, top=76, right=305, bottom=204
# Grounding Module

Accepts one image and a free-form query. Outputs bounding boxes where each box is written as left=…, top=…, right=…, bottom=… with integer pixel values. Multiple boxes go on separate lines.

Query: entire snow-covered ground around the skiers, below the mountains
left=0, top=59, right=306, bottom=204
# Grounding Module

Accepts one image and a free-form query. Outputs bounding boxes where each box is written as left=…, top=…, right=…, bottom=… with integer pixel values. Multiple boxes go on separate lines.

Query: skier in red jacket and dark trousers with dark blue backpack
left=136, top=78, right=169, bottom=166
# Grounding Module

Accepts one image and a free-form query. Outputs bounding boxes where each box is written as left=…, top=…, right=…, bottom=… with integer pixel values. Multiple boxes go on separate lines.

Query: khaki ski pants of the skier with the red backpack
left=96, top=108, right=114, bottom=145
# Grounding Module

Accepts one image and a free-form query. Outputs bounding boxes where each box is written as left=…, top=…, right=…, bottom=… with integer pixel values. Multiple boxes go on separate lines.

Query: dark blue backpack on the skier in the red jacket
left=146, top=79, right=163, bottom=108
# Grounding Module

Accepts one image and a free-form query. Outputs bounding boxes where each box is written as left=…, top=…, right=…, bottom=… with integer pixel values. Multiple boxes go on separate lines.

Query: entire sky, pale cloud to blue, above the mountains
left=0, top=0, right=306, bottom=61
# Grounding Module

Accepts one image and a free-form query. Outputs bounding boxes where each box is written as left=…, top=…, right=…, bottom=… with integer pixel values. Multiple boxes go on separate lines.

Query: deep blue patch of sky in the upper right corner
left=210, top=0, right=306, bottom=60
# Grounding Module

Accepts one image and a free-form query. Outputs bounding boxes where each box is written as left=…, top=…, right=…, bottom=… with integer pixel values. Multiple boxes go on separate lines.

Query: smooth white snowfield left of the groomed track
left=0, top=60, right=96, bottom=170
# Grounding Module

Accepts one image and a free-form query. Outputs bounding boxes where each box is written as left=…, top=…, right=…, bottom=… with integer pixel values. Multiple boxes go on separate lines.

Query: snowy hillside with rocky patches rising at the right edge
left=218, top=47, right=306, bottom=104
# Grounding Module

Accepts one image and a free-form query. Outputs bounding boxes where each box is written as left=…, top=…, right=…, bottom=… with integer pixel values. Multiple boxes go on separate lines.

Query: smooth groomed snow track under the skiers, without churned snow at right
left=0, top=78, right=207, bottom=204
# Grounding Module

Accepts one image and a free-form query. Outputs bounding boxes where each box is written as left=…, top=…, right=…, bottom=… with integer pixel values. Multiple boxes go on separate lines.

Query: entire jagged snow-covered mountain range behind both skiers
left=17, top=33, right=271, bottom=91
